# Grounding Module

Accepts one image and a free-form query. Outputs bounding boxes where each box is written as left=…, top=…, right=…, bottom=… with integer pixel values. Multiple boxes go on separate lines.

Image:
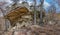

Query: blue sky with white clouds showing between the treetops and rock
left=0, top=0, right=60, bottom=12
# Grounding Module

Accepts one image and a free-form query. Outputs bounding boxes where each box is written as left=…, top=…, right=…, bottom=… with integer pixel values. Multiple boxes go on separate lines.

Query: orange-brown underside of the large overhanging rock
left=5, top=7, right=29, bottom=26
